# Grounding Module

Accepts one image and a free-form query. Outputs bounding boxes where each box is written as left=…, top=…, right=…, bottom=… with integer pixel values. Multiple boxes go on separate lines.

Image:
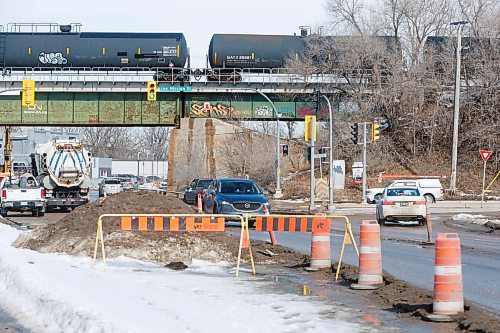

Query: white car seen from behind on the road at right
left=376, top=187, right=427, bottom=225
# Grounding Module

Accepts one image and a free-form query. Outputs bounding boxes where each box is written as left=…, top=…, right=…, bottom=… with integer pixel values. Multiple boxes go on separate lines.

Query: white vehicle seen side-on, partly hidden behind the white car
left=366, top=178, right=444, bottom=203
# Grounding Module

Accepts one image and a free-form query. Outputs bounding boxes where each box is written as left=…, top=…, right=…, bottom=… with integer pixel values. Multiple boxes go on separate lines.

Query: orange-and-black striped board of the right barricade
left=255, top=216, right=330, bottom=233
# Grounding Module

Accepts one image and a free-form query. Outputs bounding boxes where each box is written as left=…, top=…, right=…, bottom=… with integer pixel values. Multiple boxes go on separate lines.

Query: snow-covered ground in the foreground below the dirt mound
left=0, top=223, right=377, bottom=333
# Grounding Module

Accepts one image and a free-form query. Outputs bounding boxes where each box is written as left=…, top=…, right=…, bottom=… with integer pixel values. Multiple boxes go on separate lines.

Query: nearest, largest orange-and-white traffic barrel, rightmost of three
left=432, top=233, right=464, bottom=315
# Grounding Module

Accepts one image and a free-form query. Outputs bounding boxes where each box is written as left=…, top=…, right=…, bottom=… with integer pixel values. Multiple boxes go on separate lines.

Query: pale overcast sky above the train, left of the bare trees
left=0, top=0, right=327, bottom=67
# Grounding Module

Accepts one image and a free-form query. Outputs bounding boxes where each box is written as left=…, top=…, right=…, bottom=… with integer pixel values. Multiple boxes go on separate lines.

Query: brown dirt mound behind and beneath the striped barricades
left=15, top=192, right=306, bottom=265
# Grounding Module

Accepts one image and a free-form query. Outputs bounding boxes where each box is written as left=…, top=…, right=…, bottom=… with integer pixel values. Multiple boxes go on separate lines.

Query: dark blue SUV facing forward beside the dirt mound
left=202, top=178, right=271, bottom=225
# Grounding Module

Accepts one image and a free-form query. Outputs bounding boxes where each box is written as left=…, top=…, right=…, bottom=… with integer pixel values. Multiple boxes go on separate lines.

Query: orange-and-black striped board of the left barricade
left=120, top=216, right=225, bottom=231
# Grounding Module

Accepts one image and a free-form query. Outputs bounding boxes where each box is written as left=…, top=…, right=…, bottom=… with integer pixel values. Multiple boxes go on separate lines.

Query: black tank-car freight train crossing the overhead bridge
left=0, top=24, right=400, bottom=78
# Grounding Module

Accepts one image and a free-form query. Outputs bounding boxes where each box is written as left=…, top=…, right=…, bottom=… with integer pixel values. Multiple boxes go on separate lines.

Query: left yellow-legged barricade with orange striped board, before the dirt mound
left=94, top=214, right=255, bottom=276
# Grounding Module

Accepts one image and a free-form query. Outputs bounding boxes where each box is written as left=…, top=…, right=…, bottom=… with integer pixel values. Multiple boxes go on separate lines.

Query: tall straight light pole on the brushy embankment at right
left=450, top=21, right=469, bottom=194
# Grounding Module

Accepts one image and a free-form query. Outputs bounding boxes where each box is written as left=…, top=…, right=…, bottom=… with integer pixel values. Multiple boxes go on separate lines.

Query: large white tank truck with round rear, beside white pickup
left=31, top=140, right=91, bottom=211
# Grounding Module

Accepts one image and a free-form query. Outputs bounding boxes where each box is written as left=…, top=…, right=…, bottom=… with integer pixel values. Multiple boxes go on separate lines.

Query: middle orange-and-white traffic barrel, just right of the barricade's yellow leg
left=358, top=220, right=383, bottom=285
